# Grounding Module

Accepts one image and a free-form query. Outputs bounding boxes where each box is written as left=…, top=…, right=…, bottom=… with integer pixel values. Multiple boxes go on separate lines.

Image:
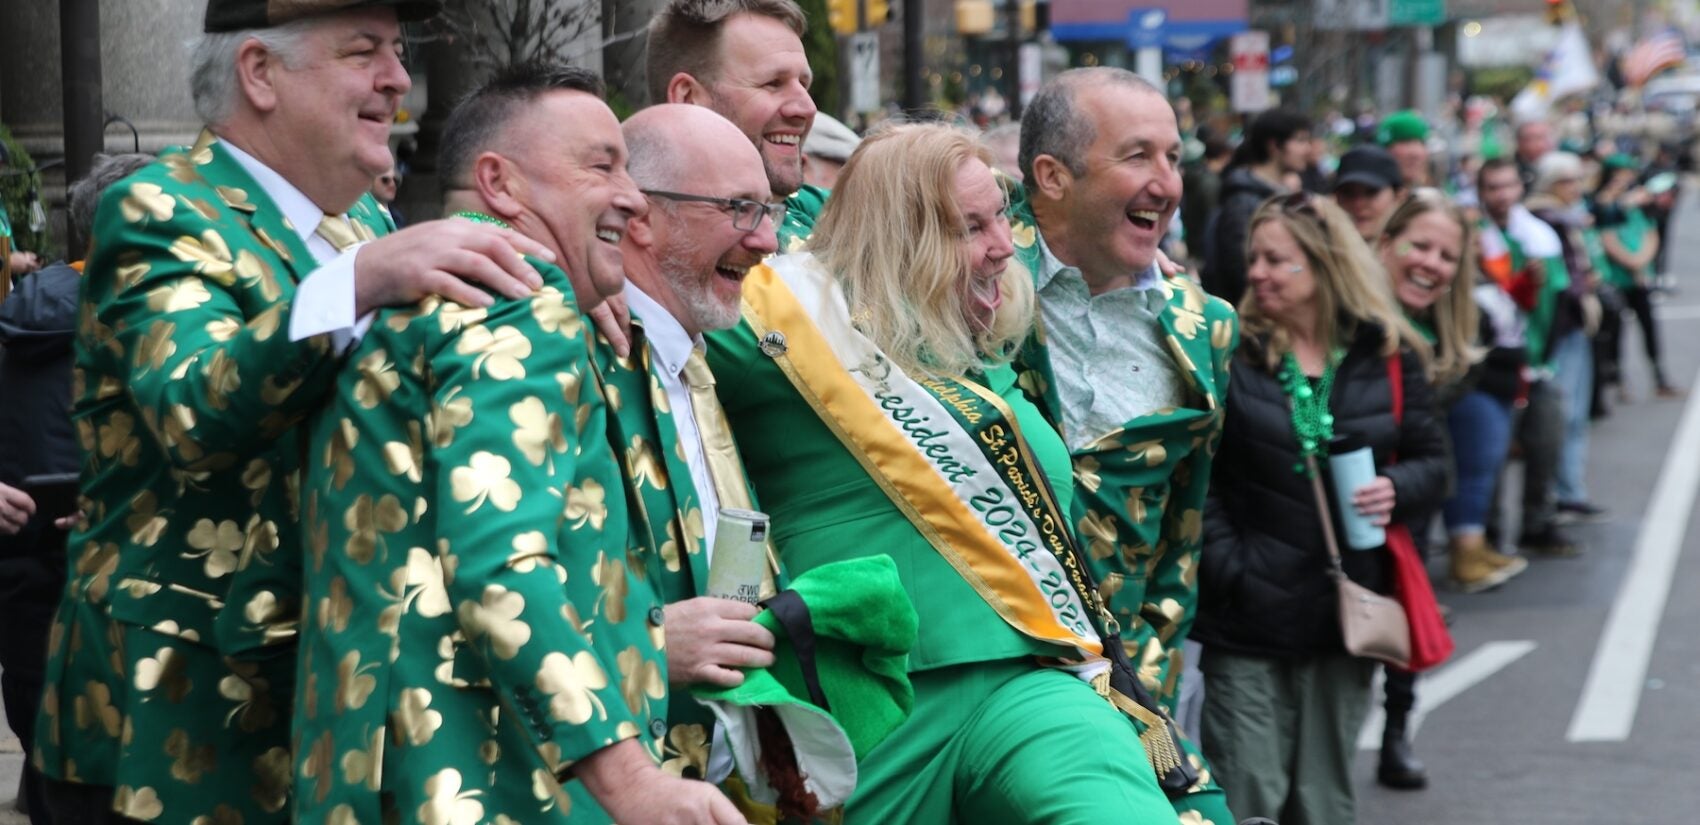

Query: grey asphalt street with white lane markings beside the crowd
left=0, top=187, right=1700, bottom=825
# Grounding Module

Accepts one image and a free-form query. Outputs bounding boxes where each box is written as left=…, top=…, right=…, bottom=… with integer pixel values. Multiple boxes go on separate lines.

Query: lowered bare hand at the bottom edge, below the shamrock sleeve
left=573, top=740, right=748, bottom=825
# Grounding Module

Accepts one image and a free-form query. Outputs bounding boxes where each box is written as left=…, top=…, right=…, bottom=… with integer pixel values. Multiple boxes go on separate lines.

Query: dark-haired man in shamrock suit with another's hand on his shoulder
left=296, top=65, right=741, bottom=823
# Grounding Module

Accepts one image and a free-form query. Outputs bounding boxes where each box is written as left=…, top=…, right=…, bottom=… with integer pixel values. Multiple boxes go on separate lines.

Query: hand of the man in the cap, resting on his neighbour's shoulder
left=354, top=219, right=554, bottom=315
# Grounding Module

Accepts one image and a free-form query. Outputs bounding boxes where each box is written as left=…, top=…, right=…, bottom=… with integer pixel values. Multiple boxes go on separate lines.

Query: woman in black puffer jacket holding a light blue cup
left=1193, top=194, right=1448, bottom=825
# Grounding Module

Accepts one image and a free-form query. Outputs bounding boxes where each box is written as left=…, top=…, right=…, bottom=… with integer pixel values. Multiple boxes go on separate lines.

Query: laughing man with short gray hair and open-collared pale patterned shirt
left=1010, top=68, right=1238, bottom=825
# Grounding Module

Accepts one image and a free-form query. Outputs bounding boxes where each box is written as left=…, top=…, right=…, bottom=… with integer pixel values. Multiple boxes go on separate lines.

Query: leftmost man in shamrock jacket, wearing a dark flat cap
left=31, top=0, right=549, bottom=825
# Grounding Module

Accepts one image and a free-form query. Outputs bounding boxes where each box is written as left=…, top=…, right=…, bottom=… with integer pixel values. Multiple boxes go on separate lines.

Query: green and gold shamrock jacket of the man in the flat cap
left=32, top=133, right=391, bottom=825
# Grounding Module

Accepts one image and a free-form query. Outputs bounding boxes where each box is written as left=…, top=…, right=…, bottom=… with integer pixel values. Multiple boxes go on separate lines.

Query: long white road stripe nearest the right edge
left=1566, top=360, right=1700, bottom=742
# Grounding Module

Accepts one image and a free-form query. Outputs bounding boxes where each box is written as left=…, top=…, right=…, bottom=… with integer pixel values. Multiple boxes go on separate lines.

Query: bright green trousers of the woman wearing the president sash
left=845, top=660, right=1176, bottom=825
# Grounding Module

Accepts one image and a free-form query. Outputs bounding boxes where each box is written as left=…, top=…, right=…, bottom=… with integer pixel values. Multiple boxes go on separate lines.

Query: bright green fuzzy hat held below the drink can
left=692, top=555, right=920, bottom=810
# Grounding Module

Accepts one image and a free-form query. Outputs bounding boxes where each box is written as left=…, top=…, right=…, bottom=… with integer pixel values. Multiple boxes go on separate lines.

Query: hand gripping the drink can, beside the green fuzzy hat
left=665, top=595, right=774, bottom=687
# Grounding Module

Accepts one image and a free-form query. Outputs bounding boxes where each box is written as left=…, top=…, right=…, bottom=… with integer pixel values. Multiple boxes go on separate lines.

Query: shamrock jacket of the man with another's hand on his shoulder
left=294, top=260, right=666, bottom=825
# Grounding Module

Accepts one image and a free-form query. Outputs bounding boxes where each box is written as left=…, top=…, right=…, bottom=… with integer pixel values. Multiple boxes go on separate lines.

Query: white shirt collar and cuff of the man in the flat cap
left=221, top=141, right=372, bottom=352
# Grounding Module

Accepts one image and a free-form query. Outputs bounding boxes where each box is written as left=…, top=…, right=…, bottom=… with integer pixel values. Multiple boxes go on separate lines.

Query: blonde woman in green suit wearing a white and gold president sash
left=709, top=126, right=1175, bottom=823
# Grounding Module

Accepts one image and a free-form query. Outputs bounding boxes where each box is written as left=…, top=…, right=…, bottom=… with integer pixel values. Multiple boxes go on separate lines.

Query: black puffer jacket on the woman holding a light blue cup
left=1193, top=325, right=1452, bottom=657
